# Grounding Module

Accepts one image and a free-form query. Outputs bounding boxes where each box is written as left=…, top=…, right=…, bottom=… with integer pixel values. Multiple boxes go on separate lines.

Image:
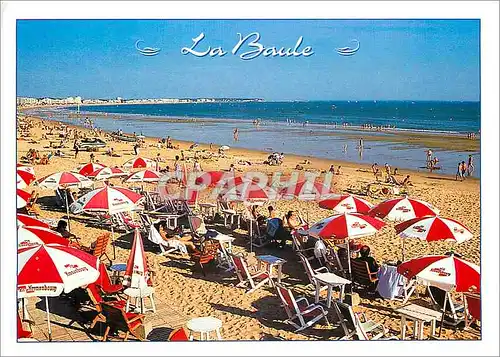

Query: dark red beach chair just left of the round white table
left=101, top=302, right=145, bottom=341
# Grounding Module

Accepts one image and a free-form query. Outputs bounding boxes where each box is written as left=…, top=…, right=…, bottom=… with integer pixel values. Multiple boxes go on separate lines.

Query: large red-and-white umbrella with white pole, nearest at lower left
left=17, top=244, right=99, bottom=340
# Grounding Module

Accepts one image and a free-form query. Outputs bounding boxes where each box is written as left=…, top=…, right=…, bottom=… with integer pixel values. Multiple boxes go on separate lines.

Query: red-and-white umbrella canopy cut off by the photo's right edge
left=398, top=254, right=481, bottom=292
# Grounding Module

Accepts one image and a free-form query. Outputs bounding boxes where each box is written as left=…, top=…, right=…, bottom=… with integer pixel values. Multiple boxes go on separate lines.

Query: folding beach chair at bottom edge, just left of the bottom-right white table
left=334, top=301, right=396, bottom=340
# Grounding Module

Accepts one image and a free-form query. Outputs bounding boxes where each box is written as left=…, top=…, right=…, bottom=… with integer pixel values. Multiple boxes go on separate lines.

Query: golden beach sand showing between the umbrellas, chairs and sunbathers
left=17, top=118, right=481, bottom=340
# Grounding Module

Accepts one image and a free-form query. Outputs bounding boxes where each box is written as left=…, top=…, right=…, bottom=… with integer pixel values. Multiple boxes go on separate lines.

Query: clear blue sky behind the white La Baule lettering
left=17, top=20, right=480, bottom=101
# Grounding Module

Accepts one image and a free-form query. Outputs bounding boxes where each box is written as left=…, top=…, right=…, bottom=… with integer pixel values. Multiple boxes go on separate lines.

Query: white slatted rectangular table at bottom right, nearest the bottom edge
left=394, top=304, right=442, bottom=340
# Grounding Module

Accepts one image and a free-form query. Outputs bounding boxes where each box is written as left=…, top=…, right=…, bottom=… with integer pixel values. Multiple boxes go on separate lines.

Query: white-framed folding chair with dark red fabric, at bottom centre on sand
left=275, top=283, right=330, bottom=332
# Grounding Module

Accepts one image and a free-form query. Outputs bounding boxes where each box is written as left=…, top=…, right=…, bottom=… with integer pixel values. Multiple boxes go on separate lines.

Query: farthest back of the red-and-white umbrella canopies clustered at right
left=368, top=197, right=439, bottom=221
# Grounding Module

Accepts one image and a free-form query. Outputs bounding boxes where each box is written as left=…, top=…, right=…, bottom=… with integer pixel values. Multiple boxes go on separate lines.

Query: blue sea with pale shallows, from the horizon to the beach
left=27, top=101, right=481, bottom=176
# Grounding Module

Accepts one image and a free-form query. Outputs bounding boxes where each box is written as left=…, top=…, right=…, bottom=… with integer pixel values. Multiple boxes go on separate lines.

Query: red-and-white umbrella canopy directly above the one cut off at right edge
left=394, top=216, right=473, bottom=243
